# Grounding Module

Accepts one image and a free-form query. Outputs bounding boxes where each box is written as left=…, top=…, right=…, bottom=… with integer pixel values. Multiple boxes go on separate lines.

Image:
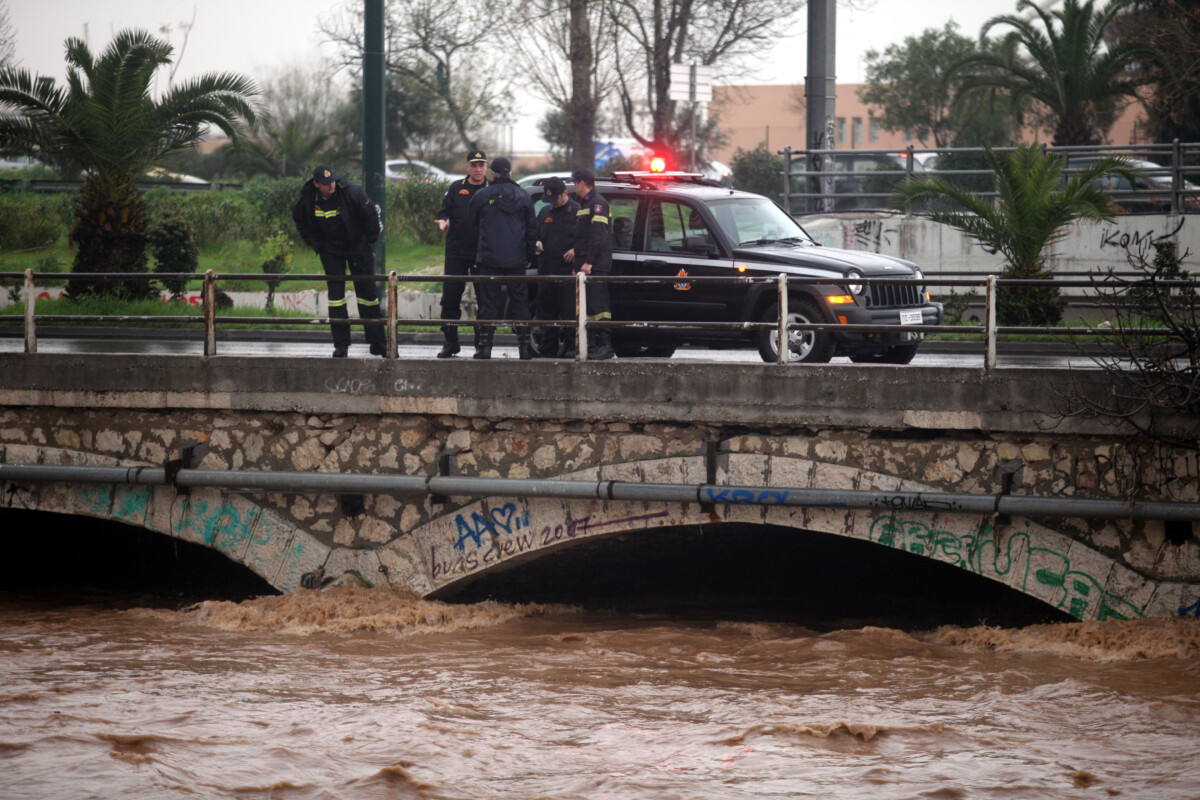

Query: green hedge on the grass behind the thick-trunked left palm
left=0, top=179, right=445, bottom=251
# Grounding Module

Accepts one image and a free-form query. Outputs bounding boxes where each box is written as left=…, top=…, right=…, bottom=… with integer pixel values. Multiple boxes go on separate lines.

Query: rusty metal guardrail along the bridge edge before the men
left=0, top=270, right=1200, bottom=372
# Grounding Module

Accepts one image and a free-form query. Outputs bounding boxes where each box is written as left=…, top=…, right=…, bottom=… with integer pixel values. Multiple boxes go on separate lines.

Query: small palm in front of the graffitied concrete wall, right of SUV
left=889, top=143, right=1138, bottom=325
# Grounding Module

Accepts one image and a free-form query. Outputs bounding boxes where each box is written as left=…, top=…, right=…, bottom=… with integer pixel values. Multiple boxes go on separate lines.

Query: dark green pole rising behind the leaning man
left=362, top=0, right=388, bottom=275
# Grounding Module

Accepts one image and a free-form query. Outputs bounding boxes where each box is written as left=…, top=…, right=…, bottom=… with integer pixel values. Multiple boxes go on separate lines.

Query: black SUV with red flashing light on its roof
left=528, top=173, right=942, bottom=363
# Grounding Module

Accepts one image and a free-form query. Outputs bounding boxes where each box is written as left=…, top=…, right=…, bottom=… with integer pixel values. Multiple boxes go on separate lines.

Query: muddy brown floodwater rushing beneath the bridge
left=0, top=588, right=1200, bottom=800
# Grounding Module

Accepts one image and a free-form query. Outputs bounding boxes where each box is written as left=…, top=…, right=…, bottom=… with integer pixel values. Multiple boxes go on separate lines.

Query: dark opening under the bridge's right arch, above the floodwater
left=433, top=523, right=1074, bottom=630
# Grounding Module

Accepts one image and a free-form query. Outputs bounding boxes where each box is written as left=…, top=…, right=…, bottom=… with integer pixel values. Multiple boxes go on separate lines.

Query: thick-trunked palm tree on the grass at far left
left=0, top=30, right=258, bottom=295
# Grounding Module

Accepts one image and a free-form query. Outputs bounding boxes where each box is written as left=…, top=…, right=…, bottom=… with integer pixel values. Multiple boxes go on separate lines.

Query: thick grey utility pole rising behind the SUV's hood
left=806, top=0, right=838, bottom=211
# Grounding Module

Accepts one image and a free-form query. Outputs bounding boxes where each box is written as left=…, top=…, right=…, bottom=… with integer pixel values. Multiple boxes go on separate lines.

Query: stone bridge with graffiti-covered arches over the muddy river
left=0, top=354, right=1200, bottom=619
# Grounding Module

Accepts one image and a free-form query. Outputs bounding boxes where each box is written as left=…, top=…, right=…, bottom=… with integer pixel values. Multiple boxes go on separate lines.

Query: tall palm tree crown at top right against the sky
left=950, top=0, right=1148, bottom=146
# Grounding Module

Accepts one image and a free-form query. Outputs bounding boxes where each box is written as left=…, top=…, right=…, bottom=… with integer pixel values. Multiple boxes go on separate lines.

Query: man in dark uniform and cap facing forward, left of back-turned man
left=437, top=150, right=487, bottom=359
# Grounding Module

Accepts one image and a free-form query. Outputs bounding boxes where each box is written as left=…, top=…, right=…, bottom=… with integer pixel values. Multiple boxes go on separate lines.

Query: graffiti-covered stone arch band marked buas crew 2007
left=396, top=453, right=1182, bottom=620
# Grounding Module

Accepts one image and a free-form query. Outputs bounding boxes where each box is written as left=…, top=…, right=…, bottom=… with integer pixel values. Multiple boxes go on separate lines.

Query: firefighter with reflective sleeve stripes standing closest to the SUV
left=564, top=167, right=617, bottom=361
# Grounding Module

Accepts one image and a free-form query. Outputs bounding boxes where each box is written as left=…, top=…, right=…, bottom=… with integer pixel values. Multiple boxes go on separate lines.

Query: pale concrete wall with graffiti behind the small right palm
left=799, top=212, right=1200, bottom=275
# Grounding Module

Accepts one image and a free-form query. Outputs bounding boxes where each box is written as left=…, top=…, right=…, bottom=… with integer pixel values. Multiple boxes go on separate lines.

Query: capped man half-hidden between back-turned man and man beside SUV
left=535, top=178, right=580, bottom=359
